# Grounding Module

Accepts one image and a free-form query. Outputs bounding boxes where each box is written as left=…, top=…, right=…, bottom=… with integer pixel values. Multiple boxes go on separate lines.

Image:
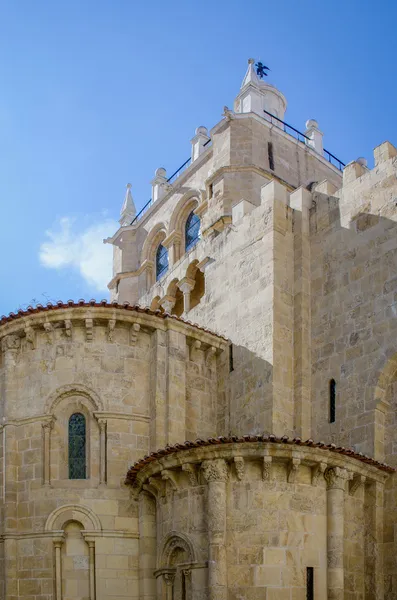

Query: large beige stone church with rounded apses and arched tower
left=0, top=59, right=397, bottom=600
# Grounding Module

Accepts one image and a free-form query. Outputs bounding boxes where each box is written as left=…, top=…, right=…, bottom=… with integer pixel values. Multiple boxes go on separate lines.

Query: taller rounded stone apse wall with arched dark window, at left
left=0, top=304, right=227, bottom=600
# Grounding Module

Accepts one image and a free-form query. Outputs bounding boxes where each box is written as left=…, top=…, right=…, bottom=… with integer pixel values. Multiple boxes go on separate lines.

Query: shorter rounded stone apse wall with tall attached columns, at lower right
left=130, top=439, right=385, bottom=600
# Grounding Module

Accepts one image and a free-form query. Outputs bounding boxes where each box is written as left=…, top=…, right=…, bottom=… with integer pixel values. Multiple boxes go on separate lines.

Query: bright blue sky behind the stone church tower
left=0, top=0, right=397, bottom=315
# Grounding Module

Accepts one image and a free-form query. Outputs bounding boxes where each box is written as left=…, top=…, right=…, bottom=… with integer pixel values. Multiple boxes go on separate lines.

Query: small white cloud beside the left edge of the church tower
left=39, top=217, right=119, bottom=291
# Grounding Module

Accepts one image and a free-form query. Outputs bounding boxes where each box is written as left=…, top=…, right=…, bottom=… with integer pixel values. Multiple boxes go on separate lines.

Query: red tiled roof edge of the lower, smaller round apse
left=125, top=435, right=396, bottom=485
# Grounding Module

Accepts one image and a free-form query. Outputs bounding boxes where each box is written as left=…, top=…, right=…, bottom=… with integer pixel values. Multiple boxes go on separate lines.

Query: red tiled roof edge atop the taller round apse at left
left=0, top=300, right=227, bottom=341
